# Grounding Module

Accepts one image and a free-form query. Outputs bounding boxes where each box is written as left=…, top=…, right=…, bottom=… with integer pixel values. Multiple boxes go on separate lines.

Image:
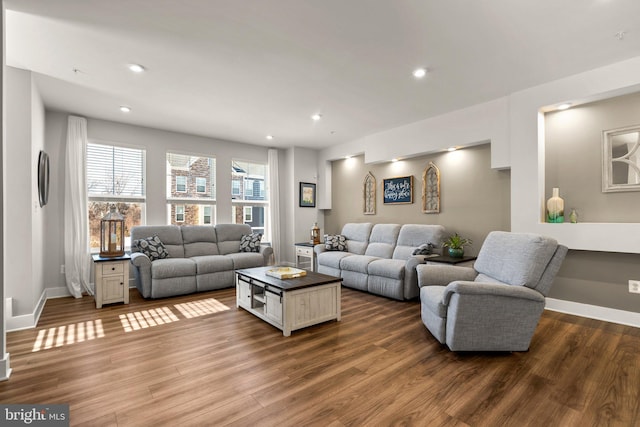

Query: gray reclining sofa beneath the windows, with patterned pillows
left=131, top=224, right=273, bottom=298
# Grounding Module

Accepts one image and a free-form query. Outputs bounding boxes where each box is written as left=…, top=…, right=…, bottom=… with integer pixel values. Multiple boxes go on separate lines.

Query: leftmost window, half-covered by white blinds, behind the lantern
left=86, top=143, right=146, bottom=251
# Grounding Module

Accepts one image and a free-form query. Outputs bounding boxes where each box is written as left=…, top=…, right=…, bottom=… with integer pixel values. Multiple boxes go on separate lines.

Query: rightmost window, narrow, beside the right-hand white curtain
left=231, top=160, right=269, bottom=234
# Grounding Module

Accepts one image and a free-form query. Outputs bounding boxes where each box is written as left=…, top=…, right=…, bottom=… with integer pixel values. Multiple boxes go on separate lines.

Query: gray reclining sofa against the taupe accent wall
left=314, top=223, right=445, bottom=300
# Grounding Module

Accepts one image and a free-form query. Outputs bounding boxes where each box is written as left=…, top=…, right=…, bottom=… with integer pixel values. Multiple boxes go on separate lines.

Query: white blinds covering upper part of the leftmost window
left=87, top=143, right=145, bottom=201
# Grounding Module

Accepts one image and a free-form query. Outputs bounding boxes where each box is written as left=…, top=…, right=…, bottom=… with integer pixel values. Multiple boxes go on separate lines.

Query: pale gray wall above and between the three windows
left=44, top=111, right=278, bottom=294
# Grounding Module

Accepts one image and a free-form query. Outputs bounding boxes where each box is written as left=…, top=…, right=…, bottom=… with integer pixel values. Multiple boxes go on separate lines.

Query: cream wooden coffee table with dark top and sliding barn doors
left=236, top=267, right=342, bottom=337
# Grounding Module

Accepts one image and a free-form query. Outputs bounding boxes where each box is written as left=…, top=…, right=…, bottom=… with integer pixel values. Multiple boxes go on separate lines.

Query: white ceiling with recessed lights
left=4, top=0, right=640, bottom=149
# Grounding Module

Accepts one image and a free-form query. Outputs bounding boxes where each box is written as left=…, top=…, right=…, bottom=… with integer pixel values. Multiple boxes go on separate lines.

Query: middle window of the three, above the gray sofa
left=166, top=153, right=216, bottom=225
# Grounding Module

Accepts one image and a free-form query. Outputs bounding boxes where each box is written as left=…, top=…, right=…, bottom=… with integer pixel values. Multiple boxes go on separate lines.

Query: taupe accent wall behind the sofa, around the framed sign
left=321, top=144, right=511, bottom=254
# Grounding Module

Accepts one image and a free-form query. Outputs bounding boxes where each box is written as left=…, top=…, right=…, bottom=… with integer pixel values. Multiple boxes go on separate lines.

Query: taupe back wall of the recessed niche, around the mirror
left=545, top=92, right=640, bottom=223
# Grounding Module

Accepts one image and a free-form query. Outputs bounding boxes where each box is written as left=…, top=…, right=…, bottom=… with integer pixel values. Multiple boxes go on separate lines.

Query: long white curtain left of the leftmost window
left=64, top=116, right=91, bottom=298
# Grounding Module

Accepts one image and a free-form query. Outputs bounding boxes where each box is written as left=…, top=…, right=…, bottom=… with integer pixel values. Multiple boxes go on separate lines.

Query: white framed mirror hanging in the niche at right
left=602, top=125, right=640, bottom=193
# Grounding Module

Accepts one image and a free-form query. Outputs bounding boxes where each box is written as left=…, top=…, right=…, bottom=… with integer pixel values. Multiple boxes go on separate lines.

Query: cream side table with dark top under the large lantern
left=91, top=254, right=131, bottom=308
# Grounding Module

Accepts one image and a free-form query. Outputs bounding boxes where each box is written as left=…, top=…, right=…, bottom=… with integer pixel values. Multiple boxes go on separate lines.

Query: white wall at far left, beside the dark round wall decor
left=3, top=67, right=45, bottom=316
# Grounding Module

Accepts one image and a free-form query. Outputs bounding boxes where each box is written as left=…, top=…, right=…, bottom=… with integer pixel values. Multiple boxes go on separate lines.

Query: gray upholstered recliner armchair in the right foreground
left=417, top=231, right=567, bottom=351
